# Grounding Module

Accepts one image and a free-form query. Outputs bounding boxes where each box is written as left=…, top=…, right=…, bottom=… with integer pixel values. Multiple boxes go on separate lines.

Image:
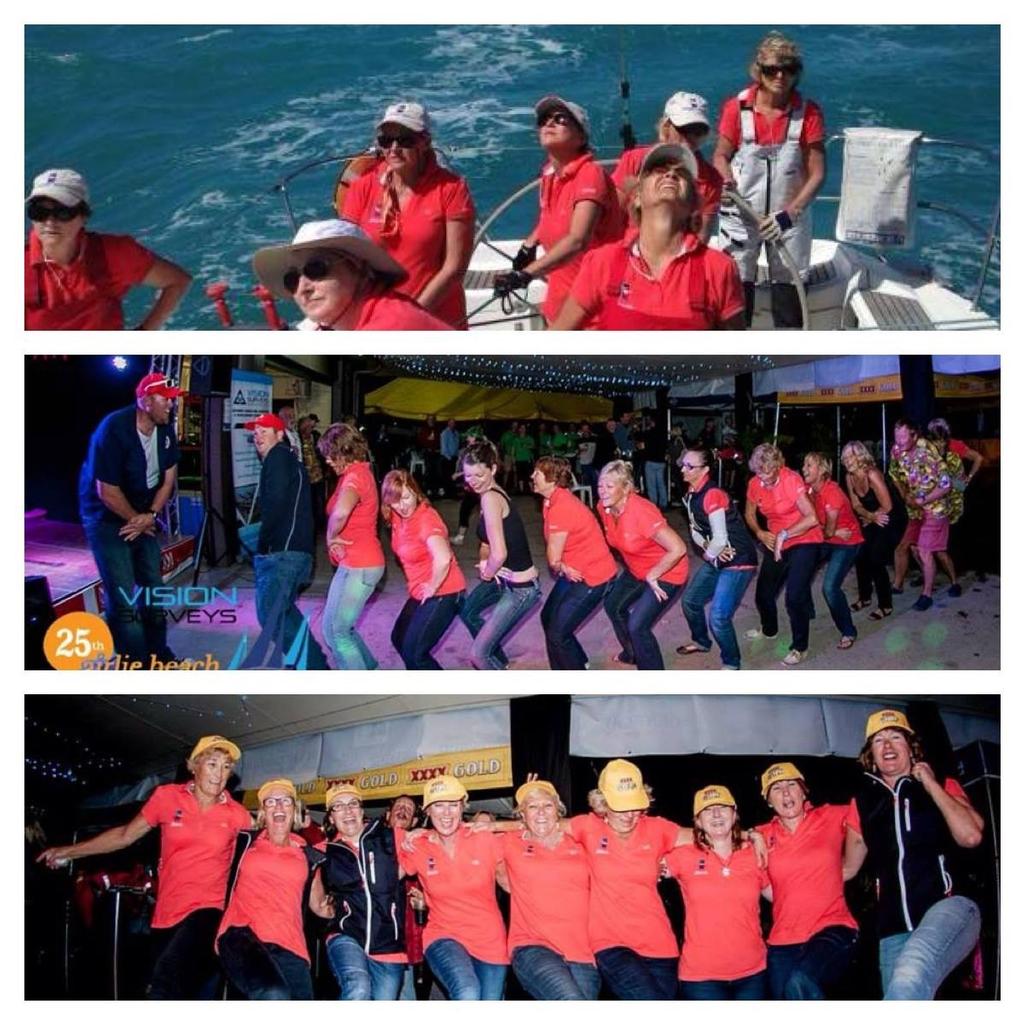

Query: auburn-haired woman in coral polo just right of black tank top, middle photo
left=530, top=456, right=615, bottom=670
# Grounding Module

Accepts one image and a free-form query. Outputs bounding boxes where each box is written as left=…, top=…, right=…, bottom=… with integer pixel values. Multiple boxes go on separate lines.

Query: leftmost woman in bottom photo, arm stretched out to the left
left=39, top=736, right=252, bottom=999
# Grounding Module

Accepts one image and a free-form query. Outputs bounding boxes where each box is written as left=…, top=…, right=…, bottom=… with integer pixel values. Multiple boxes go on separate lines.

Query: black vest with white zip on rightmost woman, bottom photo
left=855, top=772, right=955, bottom=938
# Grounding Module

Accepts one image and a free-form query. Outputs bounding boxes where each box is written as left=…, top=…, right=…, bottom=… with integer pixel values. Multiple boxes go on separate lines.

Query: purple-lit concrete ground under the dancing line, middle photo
left=169, top=497, right=999, bottom=672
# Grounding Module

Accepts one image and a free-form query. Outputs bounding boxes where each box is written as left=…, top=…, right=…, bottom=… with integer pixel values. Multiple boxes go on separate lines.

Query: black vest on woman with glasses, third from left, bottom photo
left=321, top=818, right=406, bottom=953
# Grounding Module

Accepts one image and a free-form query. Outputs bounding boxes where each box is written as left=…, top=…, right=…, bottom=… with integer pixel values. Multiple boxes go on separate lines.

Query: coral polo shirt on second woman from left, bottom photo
left=217, top=833, right=309, bottom=964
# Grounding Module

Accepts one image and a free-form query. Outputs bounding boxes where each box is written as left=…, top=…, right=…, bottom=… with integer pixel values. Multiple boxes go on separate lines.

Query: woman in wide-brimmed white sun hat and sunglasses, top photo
left=253, top=220, right=452, bottom=331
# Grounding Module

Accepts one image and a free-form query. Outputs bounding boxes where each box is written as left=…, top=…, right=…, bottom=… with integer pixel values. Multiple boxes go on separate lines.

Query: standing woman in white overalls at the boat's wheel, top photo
left=714, top=32, right=825, bottom=328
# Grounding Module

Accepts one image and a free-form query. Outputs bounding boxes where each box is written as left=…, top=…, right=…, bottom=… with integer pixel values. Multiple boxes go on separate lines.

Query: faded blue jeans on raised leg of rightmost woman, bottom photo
left=879, top=896, right=981, bottom=999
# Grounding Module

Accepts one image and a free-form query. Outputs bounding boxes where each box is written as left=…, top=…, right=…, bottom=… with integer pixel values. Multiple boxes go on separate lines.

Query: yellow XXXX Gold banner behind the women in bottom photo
left=245, top=746, right=512, bottom=809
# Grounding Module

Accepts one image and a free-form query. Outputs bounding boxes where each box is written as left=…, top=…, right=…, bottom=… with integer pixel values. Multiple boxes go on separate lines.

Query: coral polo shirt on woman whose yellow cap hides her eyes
left=568, top=814, right=679, bottom=956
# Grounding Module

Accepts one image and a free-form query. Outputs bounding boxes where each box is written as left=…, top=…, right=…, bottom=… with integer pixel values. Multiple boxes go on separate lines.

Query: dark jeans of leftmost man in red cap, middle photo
left=85, top=522, right=174, bottom=668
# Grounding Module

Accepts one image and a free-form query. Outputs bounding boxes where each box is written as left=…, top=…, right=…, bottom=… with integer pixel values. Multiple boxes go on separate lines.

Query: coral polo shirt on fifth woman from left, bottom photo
left=501, top=831, right=594, bottom=964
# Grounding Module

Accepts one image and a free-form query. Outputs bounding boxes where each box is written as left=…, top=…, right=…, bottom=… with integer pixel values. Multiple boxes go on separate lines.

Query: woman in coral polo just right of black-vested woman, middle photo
left=743, top=443, right=824, bottom=666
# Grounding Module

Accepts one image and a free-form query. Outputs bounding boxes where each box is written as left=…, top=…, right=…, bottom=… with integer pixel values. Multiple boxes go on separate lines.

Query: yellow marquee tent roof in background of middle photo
left=365, top=377, right=611, bottom=423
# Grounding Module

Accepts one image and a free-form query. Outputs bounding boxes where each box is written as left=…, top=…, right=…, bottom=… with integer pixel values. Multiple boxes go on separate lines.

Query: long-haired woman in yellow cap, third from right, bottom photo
left=665, top=785, right=769, bottom=999
